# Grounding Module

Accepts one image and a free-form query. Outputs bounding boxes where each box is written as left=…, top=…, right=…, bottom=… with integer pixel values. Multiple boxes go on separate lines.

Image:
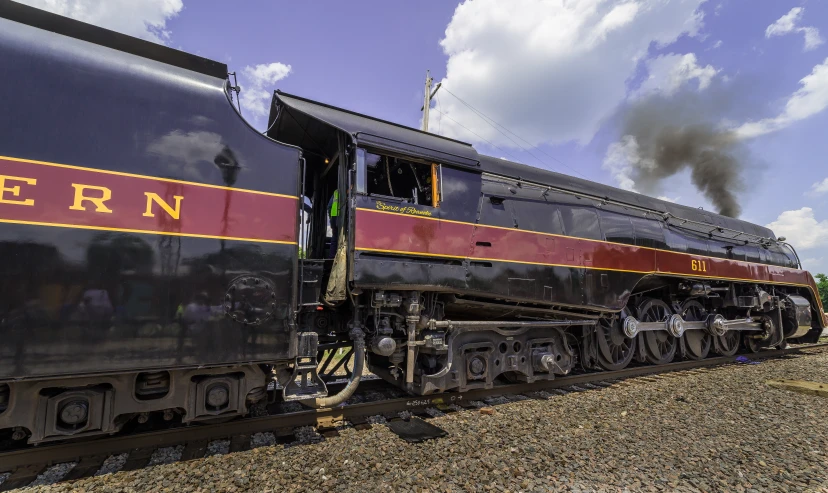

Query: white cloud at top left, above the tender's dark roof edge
left=16, top=0, right=184, bottom=44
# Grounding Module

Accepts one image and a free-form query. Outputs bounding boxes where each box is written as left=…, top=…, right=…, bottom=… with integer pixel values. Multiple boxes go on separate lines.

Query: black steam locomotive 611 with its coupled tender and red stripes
left=0, top=2, right=826, bottom=443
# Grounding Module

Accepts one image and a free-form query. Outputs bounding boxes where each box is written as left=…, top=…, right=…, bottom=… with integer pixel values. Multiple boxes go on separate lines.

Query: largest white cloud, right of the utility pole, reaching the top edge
left=431, top=0, right=704, bottom=146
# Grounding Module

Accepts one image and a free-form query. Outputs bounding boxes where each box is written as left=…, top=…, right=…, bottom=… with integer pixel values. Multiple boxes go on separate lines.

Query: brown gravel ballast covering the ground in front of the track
left=11, top=351, right=828, bottom=493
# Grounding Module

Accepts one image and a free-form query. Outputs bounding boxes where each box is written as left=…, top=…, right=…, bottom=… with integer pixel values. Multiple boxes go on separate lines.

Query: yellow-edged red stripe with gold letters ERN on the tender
left=0, top=158, right=298, bottom=243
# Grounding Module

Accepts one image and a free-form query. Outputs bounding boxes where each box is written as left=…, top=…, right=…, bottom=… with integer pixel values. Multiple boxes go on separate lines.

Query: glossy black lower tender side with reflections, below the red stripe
left=0, top=226, right=292, bottom=376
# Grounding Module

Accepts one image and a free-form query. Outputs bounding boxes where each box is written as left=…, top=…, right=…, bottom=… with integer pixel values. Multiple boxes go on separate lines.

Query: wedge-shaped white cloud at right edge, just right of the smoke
left=736, top=58, right=828, bottom=138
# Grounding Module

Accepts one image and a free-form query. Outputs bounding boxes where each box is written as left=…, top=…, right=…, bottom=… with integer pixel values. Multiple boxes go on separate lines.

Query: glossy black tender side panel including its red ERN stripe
left=0, top=15, right=299, bottom=380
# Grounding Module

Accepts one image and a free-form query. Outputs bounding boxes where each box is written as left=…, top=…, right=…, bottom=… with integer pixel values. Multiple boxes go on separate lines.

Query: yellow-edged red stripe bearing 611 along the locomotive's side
left=355, top=205, right=819, bottom=303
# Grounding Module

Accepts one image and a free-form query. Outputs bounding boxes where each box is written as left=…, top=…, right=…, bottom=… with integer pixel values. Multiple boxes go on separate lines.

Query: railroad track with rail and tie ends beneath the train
left=0, top=343, right=828, bottom=491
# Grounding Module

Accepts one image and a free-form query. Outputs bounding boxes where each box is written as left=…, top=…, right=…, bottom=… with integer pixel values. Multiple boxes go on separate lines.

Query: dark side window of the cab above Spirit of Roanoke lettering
left=365, top=152, right=433, bottom=205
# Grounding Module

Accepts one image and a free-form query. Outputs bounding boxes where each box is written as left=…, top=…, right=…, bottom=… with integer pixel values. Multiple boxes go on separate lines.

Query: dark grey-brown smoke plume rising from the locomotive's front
left=604, top=92, right=747, bottom=217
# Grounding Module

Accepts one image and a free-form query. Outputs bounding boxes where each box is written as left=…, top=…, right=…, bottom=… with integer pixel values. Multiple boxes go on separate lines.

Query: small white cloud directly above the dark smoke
left=636, top=53, right=719, bottom=96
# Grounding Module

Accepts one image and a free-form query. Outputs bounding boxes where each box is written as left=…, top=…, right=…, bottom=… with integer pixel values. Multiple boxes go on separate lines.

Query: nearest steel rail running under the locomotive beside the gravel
left=0, top=343, right=828, bottom=472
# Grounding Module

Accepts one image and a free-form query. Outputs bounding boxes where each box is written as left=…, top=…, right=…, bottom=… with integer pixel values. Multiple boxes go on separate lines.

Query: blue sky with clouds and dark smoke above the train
left=11, top=0, right=828, bottom=273
